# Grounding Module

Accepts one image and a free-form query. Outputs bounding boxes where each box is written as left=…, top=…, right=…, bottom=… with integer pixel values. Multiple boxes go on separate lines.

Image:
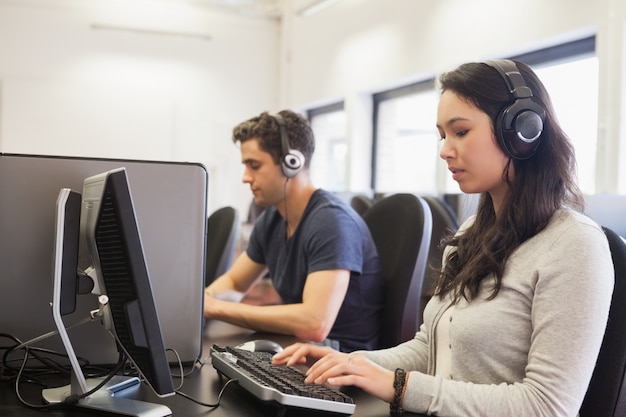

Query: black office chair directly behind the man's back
left=363, top=194, right=432, bottom=348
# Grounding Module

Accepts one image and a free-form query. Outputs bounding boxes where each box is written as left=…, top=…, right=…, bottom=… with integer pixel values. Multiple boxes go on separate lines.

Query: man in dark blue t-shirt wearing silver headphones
left=204, top=110, right=384, bottom=352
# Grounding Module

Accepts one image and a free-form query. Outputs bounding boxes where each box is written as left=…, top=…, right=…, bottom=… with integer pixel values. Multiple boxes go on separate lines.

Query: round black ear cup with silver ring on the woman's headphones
left=496, top=100, right=545, bottom=159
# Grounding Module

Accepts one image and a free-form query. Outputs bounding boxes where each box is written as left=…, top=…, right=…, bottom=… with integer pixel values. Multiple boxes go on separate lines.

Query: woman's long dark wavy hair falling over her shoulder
left=435, top=62, right=583, bottom=301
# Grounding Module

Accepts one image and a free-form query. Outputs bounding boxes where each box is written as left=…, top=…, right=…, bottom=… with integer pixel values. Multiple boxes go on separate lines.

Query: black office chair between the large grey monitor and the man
left=204, top=206, right=240, bottom=286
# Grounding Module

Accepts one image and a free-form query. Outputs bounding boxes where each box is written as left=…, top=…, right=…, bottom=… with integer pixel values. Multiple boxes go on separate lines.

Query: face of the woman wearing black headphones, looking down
left=437, top=90, right=513, bottom=212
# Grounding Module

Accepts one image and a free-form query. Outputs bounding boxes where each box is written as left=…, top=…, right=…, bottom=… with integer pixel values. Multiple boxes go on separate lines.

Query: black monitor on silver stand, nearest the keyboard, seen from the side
left=43, top=168, right=174, bottom=416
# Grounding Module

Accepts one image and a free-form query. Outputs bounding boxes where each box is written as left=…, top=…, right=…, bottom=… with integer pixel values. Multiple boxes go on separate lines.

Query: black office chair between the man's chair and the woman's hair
left=420, top=196, right=459, bottom=321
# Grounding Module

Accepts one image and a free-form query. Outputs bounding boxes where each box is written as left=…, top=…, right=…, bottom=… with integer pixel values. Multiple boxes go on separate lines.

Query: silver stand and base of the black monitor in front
left=42, top=189, right=172, bottom=417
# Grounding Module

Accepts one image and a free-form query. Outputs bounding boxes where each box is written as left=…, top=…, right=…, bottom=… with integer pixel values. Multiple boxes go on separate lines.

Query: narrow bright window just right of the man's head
left=307, top=102, right=348, bottom=192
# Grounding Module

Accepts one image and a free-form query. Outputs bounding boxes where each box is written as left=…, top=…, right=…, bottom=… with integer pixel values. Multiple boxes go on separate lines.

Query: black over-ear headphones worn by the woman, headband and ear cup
left=485, top=59, right=546, bottom=159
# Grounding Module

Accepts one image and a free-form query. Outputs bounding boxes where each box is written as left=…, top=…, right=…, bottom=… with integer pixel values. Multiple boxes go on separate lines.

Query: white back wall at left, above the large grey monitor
left=0, top=0, right=279, bottom=216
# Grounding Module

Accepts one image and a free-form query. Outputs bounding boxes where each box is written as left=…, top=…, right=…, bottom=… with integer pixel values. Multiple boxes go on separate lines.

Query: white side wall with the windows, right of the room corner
left=281, top=0, right=626, bottom=192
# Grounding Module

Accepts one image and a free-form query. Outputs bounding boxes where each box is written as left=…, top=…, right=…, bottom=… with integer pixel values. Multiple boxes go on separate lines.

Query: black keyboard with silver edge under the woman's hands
left=211, top=345, right=356, bottom=414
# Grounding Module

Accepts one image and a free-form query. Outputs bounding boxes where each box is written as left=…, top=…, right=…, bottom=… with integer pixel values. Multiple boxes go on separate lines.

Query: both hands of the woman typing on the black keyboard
left=273, top=343, right=394, bottom=402
